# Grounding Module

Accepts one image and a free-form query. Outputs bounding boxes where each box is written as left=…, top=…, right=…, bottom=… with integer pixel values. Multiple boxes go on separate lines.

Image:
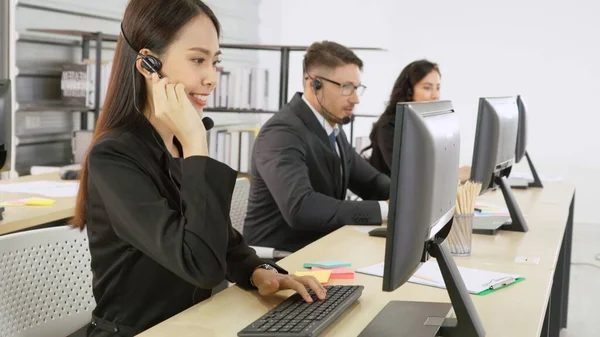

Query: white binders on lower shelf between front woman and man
left=208, top=125, right=259, bottom=174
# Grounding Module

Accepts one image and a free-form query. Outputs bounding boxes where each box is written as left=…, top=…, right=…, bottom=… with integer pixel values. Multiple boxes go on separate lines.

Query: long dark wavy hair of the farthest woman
left=361, top=60, right=442, bottom=153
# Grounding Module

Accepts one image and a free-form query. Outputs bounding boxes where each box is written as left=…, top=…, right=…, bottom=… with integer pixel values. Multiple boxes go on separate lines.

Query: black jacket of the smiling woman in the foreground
left=81, top=115, right=285, bottom=337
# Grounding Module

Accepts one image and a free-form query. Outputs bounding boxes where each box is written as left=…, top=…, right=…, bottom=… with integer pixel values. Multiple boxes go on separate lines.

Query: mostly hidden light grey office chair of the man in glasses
left=229, top=178, right=291, bottom=260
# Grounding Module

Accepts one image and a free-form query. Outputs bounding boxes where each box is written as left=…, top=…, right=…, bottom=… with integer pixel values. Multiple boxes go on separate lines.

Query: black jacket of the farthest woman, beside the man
left=369, top=115, right=396, bottom=177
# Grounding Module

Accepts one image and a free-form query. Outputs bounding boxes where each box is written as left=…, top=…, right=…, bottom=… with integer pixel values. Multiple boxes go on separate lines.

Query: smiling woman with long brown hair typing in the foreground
left=72, top=0, right=325, bottom=336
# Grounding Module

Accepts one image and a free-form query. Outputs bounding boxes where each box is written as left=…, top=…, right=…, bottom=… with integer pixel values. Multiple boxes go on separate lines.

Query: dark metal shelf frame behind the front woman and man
left=28, top=29, right=384, bottom=124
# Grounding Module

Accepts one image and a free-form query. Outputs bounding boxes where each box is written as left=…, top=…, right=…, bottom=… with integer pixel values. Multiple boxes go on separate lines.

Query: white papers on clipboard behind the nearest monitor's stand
left=356, top=259, right=525, bottom=295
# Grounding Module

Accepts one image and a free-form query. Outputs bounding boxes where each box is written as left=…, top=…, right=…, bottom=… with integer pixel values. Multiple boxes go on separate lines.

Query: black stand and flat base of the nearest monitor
left=359, top=238, right=485, bottom=337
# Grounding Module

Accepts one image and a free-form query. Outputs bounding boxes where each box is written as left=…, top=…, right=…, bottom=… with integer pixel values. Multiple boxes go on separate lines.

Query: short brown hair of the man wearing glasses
left=303, top=41, right=363, bottom=73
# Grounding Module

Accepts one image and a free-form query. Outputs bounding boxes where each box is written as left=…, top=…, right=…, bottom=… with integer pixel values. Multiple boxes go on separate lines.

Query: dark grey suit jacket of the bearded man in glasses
left=244, top=93, right=390, bottom=251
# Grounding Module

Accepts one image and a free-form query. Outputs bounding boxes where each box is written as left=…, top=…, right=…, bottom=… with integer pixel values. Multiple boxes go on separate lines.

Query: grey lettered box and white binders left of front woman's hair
left=60, top=60, right=112, bottom=109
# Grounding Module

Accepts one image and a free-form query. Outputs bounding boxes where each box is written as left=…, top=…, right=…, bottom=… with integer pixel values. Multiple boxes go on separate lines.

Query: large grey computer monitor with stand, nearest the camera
left=363, top=101, right=485, bottom=336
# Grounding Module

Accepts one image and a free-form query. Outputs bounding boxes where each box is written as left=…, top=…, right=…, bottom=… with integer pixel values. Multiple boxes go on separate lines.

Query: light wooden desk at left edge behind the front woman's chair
left=0, top=173, right=75, bottom=235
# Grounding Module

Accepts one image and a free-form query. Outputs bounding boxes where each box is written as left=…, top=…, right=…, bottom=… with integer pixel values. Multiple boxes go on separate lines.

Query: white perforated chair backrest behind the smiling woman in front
left=0, top=226, right=96, bottom=337
